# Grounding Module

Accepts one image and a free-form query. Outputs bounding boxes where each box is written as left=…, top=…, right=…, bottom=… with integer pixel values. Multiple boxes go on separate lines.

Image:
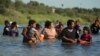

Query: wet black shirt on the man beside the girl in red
left=60, top=27, right=79, bottom=43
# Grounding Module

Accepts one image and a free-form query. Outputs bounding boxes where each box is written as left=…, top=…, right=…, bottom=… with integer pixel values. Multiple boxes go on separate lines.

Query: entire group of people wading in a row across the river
left=3, top=18, right=100, bottom=45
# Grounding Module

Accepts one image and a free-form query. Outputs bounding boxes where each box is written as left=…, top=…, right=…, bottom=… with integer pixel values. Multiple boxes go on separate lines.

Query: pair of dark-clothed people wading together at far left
left=3, top=20, right=19, bottom=37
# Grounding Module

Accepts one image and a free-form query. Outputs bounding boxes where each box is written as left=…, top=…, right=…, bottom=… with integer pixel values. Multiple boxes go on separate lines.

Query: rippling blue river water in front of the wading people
left=0, top=27, right=100, bottom=56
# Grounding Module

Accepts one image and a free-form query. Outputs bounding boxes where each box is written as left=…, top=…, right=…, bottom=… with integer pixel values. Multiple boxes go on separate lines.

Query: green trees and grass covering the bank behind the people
left=0, top=0, right=100, bottom=24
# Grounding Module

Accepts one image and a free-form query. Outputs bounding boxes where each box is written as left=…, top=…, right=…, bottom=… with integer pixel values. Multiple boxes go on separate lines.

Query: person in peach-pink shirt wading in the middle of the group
left=42, top=21, right=57, bottom=39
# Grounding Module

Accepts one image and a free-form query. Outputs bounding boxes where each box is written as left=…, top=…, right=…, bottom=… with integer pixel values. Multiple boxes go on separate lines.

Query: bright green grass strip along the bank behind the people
left=0, top=13, right=88, bottom=24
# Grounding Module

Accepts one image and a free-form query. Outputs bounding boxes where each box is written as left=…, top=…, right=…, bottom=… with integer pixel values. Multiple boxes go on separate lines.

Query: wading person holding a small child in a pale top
left=22, top=20, right=38, bottom=45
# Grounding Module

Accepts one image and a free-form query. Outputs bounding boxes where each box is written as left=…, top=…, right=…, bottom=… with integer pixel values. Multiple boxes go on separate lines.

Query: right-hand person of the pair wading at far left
left=10, top=22, right=19, bottom=37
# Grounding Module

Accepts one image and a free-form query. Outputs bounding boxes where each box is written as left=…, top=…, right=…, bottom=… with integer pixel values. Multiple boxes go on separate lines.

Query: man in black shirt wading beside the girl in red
left=61, top=20, right=79, bottom=44
